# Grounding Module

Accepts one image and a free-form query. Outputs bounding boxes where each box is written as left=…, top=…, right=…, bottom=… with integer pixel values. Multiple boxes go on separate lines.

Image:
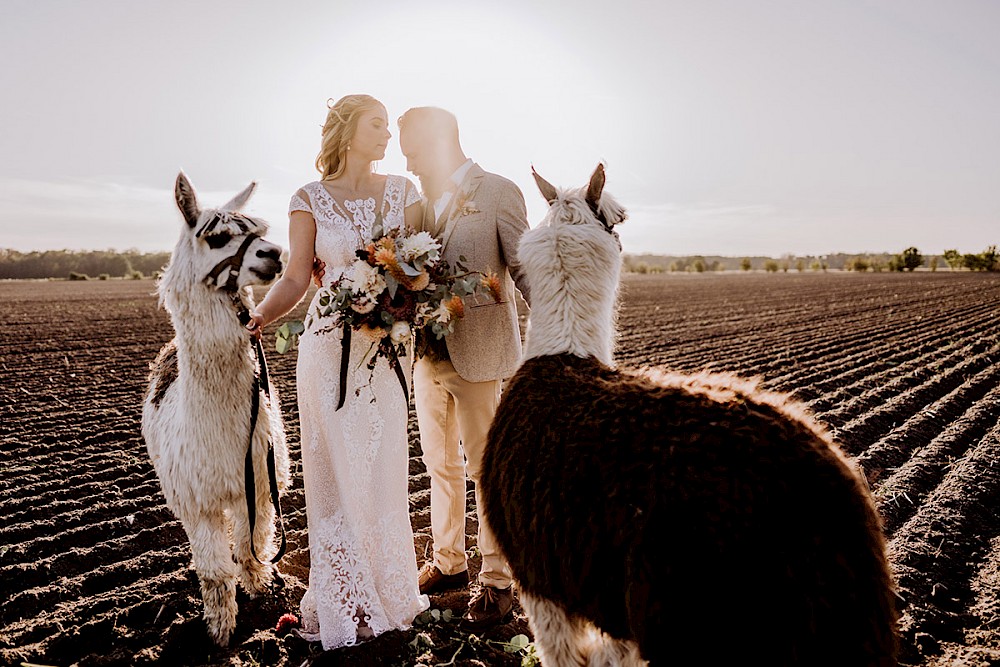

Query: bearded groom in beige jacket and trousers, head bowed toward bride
left=399, top=107, right=531, bottom=629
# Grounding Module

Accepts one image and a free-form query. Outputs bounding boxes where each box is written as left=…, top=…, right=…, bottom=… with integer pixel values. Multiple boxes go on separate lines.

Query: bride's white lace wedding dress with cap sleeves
left=289, top=176, right=429, bottom=650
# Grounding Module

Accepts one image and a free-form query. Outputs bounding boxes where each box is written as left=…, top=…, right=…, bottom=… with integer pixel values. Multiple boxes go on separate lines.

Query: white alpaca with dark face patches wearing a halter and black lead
left=142, top=172, right=289, bottom=646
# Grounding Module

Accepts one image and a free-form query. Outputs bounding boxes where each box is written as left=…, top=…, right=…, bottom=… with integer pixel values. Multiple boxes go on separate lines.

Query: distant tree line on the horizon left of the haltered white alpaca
left=0, top=248, right=170, bottom=280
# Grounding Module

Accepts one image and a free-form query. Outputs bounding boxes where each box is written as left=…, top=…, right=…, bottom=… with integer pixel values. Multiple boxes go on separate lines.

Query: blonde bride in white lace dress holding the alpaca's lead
left=247, top=95, right=429, bottom=650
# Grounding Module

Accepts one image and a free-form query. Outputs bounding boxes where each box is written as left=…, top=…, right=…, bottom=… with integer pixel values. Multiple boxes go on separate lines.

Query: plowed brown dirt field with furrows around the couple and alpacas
left=0, top=272, right=1000, bottom=667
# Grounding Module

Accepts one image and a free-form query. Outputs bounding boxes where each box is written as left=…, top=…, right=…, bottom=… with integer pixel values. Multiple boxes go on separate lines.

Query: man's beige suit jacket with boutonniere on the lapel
left=425, top=164, right=531, bottom=382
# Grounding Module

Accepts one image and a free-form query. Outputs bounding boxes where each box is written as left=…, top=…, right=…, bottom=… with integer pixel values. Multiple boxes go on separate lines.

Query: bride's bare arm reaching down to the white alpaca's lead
left=247, top=211, right=316, bottom=333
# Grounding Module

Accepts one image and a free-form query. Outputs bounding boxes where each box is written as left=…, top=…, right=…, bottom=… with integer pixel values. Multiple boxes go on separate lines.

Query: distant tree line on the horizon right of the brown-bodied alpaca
left=623, top=246, right=1000, bottom=273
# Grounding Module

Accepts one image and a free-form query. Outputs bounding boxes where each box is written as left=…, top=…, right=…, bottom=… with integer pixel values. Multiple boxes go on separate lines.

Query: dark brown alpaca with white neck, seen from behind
left=482, top=167, right=897, bottom=667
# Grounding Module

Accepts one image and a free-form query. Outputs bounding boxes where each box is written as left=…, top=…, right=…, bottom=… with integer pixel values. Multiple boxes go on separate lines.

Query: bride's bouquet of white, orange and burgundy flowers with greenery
left=275, top=214, right=501, bottom=369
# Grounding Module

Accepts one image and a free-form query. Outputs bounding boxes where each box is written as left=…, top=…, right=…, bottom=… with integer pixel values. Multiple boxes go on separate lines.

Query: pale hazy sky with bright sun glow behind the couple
left=0, top=0, right=1000, bottom=256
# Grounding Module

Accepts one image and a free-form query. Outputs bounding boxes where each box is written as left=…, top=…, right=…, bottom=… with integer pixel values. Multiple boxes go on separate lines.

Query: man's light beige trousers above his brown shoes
left=413, top=357, right=512, bottom=588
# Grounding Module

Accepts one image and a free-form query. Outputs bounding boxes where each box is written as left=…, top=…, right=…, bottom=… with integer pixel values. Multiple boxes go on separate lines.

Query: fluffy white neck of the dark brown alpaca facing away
left=518, top=225, right=621, bottom=366
